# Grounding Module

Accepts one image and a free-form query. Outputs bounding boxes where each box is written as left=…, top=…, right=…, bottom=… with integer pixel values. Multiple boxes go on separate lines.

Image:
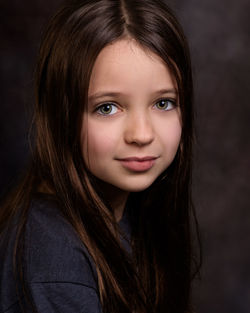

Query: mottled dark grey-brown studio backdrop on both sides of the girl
left=0, top=0, right=250, bottom=313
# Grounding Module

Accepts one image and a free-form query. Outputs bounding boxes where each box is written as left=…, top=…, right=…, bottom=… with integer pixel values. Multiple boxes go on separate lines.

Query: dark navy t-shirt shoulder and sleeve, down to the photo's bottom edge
left=24, top=196, right=102, bottom=313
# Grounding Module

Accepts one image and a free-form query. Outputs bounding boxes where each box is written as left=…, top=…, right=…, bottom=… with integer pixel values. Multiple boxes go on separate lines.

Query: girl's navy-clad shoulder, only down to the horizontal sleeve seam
left=25, top=197, right=97, bottom=289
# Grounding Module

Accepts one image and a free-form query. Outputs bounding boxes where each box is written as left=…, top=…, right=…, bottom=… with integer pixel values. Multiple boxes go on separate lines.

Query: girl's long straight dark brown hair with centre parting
left=0, top=0, right=198, bottom=313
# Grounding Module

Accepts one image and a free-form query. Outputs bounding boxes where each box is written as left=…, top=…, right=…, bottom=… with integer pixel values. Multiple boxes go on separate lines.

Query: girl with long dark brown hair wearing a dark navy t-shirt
left=0, top=0, right=197, bottom=313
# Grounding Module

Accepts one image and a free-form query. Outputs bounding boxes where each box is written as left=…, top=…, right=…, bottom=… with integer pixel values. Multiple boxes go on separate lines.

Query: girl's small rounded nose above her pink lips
left=124, top=113, right=154, bottom=146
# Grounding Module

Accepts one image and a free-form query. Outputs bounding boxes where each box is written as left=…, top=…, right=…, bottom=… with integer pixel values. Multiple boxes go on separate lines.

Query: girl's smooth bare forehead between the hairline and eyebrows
left=89, top=39, right=175, bottom=94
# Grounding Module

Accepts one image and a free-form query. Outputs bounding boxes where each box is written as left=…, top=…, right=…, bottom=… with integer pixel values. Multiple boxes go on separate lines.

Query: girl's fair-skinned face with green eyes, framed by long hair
left=81, top=39, right=181, bottom=192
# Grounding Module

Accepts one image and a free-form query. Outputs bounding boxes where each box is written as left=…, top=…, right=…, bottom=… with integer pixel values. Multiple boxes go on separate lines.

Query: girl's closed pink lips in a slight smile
left=115, top=156, right=158, bottom=172
